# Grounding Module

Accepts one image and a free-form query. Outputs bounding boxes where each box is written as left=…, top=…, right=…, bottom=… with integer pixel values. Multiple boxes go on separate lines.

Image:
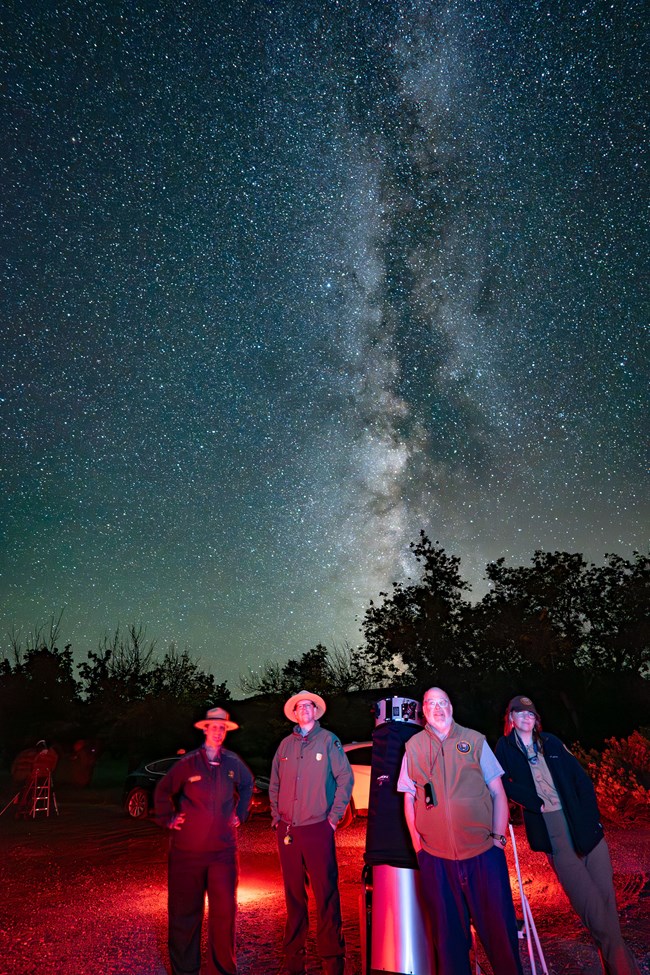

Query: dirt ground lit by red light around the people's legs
left=0, top=785, right=650, bottom=975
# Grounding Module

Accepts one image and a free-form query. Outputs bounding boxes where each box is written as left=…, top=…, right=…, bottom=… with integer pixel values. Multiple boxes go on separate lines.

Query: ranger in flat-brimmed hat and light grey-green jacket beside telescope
left=269, top=691, right=353, bottom=975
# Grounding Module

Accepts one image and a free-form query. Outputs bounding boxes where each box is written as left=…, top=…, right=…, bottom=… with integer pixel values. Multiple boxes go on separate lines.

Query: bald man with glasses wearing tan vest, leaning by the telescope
left=397, top=687, right=522, bottom=975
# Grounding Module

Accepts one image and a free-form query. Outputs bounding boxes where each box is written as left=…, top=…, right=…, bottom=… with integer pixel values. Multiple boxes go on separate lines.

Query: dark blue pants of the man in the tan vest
left=418, top=846, right=523, bottom=975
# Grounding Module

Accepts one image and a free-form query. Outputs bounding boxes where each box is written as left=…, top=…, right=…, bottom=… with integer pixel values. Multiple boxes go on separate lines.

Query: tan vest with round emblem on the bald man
left=406, top=722, right=493, bottom=860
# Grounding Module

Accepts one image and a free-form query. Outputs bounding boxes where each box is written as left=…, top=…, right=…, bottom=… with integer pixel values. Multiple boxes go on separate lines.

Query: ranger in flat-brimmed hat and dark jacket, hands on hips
left=154, top=708, right=253, bottom=975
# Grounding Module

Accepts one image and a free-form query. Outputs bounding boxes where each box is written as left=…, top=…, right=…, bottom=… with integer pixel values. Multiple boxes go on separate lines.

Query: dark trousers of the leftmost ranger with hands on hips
left=168, top=849, right=239, bottom=975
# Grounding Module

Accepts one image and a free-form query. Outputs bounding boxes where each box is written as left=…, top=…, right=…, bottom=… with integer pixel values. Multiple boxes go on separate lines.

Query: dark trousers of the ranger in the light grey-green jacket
left=277, top=820, right=345, bottom=975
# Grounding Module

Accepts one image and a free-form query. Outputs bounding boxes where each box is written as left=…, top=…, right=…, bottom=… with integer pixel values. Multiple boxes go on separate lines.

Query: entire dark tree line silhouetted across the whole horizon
left=0, top=532, right=650, bottom=764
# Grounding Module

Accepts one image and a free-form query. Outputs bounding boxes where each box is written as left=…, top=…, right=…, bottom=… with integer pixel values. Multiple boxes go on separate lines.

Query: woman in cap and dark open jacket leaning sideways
left=496, top=694, right=639, bottom=975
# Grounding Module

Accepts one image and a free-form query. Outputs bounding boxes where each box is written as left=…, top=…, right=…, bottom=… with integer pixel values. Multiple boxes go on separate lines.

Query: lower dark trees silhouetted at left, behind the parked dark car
left=0, top=615, right=231, bottom=765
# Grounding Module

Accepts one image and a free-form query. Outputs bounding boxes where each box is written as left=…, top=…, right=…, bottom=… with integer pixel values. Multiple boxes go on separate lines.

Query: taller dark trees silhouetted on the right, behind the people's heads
left=242, top=532, right=650, bottom=752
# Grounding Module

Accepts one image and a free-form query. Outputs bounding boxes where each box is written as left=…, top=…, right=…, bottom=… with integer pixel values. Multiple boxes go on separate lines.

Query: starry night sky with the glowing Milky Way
left=0, top=0, right=649, bottom=696
